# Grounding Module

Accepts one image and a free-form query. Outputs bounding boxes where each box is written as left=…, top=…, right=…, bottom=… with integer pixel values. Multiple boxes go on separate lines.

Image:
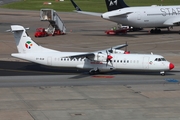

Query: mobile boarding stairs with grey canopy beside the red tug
left=40, top=9, right=66, bottom=35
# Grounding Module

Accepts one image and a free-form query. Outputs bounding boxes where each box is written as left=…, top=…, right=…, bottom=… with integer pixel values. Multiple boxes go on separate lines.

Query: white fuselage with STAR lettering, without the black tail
left=102, top=6, right=180, bottom=28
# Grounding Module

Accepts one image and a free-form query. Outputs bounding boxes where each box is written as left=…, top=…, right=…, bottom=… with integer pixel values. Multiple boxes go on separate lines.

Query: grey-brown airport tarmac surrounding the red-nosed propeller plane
left=0, top=9, right=180, bottom=120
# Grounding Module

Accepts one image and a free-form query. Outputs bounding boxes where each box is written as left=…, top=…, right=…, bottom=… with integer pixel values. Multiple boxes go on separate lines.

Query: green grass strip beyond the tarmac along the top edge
left=0, top=0, right=180, bottom=12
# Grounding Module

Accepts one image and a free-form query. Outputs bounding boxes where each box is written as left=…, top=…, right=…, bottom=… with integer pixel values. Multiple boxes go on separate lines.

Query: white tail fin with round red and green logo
left=11, top=25, right=40, bottom=53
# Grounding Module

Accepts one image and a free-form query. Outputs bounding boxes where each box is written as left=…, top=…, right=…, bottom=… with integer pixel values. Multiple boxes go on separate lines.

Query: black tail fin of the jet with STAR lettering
left=105, top=0, right=129, bottom=11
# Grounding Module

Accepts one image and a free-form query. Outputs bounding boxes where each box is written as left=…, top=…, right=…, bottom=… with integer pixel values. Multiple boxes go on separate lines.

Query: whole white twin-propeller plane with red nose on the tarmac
left=11, top=25, right=174, bottom=75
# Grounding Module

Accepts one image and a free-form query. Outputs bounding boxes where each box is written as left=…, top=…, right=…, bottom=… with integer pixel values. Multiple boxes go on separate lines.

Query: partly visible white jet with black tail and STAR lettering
left=71, top=0, right=180, bottom=33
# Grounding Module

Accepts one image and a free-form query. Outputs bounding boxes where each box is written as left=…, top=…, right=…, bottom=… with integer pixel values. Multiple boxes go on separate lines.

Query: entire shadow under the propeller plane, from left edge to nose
left=0, top=61, right=177, bottom=79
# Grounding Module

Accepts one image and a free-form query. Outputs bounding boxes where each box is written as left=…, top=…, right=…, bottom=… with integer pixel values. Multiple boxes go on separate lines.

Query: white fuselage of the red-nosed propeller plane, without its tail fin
left=12, top=52, right=170, bottom=72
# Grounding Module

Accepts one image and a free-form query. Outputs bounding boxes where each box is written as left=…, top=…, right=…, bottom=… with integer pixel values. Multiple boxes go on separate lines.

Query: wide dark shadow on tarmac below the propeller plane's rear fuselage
left=0, top=61, right=87, bottom=76
